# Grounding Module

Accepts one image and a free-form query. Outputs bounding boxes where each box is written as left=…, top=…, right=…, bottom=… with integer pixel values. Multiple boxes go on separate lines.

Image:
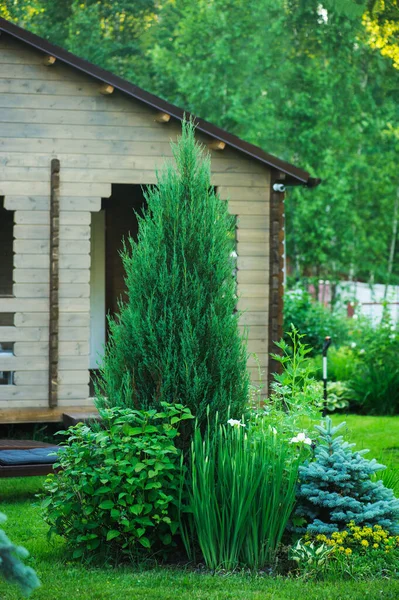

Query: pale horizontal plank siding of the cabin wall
left=0, top=35, right=270, bottom=422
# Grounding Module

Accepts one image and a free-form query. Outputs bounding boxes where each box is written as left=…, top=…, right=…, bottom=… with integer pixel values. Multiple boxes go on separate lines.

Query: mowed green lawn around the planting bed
left=0, top=416, right=399, bottom=600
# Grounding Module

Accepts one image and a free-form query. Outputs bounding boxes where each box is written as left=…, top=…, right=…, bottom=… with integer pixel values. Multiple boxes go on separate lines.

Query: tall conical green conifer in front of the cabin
left=98, top=122, right=249, bottom=423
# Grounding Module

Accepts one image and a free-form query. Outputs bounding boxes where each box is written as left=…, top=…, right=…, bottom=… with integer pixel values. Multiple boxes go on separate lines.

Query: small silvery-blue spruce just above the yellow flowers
left=294, top=417, right=399, bottom=534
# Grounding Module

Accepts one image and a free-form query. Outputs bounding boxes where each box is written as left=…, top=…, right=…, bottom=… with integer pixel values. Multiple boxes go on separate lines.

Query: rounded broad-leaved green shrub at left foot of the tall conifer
left=43, top=403, right=192, bottom=560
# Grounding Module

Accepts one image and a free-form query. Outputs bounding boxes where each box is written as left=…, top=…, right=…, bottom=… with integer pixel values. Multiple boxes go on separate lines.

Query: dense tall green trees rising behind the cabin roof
left=0, top=0, right=399, bottom=282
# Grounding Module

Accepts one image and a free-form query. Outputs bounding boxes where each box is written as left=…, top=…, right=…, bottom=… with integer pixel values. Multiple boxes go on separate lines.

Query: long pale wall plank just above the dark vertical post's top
left=0, top=137, right=172, bottom=157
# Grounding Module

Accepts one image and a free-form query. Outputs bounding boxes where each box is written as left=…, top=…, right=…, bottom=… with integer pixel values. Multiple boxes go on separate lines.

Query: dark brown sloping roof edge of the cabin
left=0, top=17, right=321, bottom=187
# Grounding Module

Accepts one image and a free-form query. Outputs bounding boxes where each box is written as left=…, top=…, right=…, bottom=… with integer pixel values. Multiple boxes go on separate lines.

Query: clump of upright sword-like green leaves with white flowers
left=182, top=420, right=299, bottom=570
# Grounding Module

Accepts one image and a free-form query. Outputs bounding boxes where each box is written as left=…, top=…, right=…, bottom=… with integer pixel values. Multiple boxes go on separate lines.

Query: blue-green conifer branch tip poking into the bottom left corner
left=0, top=513, right=40, bottom=596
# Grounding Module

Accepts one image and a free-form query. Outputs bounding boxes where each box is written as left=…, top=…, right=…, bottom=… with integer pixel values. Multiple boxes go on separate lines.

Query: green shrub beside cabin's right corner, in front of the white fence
left=284, top=289, right=348, bottom=354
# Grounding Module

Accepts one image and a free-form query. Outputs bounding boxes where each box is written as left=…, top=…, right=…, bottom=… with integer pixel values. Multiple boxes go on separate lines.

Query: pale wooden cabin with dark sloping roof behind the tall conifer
left=0, top=19, right=318, bottom=423
